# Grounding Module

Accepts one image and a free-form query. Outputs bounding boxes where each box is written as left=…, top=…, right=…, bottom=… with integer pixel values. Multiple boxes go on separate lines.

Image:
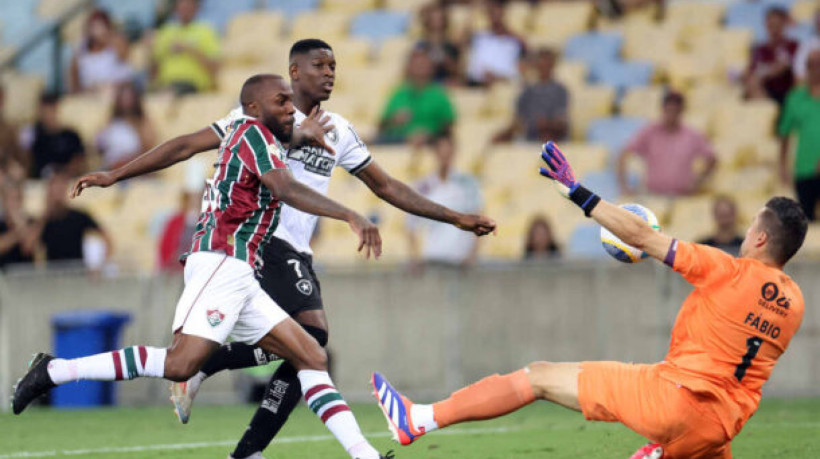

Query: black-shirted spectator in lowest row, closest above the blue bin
left=28, top=170, right=112, bottom=261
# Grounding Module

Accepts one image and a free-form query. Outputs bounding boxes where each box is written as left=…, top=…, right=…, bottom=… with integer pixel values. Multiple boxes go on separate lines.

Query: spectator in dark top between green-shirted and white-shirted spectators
left=416, top=3, right=461, bottom=84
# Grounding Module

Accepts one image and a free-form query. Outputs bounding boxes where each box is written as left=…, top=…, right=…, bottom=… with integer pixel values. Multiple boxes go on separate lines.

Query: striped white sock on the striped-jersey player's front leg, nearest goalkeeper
left=296, top=370, right=379, bottom=459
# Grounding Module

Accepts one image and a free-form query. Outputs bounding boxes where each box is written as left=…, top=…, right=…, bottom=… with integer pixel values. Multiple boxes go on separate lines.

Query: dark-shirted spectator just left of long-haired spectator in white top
left=20, top=94, right=85, bottom=178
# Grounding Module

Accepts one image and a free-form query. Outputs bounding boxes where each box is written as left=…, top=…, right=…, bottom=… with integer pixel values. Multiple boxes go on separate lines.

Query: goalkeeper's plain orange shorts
left=578, top=362, right=732, bottom=459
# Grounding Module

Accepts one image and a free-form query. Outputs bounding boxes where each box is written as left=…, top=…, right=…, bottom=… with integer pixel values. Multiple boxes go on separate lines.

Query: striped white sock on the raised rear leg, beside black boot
left=48, top=346, right=168, bottom=384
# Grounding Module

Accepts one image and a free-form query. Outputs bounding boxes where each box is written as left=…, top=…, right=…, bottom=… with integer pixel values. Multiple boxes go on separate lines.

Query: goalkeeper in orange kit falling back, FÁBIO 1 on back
left=372, top=142, right=808, bottom=459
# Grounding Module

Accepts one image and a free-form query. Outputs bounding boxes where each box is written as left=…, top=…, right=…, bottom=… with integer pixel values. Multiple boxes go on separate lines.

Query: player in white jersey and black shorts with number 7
left=72, top=39, right=495, bottom=459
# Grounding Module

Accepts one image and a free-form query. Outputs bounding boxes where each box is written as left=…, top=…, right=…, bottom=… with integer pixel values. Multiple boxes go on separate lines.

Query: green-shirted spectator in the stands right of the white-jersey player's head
left=379, top=49, right=455, bottom=145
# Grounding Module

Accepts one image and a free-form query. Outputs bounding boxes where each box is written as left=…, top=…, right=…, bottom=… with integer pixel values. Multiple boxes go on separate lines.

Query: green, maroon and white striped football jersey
left=191, top=116, right=287, bottom=268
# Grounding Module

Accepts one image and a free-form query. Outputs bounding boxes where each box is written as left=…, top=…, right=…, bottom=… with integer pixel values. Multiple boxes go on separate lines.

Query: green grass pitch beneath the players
left=0, top=399, right=820, bottom=459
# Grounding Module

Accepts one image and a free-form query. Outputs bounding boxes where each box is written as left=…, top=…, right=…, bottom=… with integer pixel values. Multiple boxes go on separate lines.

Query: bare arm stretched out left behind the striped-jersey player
left=71, top=127, right=220, bottom=198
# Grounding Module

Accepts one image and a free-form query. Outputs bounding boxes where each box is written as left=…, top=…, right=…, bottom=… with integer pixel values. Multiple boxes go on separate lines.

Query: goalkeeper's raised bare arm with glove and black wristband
left=541, top=142, right=672, bottom=261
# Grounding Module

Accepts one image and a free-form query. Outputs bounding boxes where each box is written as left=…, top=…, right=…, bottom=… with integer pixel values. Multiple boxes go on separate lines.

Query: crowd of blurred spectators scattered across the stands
left=0, top=0, right=820, bottom=274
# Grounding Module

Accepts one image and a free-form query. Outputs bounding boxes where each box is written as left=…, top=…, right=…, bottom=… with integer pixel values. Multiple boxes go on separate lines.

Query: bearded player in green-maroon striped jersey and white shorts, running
left=12, top=75, right=390, bottom=459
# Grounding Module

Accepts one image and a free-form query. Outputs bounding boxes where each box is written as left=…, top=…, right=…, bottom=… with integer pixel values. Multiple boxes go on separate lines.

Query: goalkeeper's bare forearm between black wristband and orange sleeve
left=590, top=199, right=672, bottom=261
